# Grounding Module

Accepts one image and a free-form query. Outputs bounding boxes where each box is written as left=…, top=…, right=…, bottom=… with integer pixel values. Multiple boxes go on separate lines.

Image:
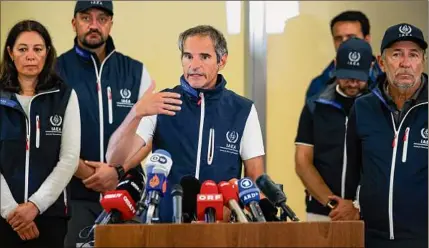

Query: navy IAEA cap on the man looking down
left=335, top=38, right=373, bottom=81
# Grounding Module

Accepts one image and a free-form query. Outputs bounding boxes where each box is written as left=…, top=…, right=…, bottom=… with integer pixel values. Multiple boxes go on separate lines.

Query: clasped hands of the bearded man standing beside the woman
left=82, top=161, right=119, bottom=192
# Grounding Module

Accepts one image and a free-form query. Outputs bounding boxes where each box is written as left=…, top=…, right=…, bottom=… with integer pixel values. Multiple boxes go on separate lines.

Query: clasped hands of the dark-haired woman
left=7, top=201, right=39, bottom=232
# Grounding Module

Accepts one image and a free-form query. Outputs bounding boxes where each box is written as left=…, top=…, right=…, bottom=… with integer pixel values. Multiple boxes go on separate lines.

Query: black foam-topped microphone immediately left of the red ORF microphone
left=180, top=175, right=201, bottom=223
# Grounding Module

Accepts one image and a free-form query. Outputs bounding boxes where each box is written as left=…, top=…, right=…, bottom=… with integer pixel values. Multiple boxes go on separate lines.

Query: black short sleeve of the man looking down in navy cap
left=295, top=104, right=314, bottom=146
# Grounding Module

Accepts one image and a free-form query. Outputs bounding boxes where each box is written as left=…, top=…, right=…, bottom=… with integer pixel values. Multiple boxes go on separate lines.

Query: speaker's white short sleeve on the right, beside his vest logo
left=240, top=105, right=265, bottom=160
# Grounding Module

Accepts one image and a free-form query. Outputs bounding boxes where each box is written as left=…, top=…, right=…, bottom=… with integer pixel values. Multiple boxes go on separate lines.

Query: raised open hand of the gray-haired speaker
left=133, top=80, right=182, bottom=118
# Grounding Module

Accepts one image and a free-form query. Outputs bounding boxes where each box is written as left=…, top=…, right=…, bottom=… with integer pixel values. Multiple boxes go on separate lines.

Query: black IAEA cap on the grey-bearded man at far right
left=381, top=23, right=428, bottom=53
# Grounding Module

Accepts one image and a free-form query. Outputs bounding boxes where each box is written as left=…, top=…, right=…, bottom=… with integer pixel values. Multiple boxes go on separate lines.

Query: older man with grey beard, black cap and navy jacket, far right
left=347, top=23, right=428, bottom=248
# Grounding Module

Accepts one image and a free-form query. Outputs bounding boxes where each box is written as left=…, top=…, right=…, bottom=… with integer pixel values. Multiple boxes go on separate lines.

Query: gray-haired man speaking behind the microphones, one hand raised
left=107, top=25, right=265, bottom=222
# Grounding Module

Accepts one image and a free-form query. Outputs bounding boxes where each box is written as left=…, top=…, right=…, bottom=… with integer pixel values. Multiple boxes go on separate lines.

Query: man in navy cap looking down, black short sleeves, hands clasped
left=295, top=38, right=372, bottom=221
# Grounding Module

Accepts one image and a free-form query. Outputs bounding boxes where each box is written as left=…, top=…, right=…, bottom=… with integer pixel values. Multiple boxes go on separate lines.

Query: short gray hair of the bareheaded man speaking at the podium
left=179, top=25, right=228, bottom=63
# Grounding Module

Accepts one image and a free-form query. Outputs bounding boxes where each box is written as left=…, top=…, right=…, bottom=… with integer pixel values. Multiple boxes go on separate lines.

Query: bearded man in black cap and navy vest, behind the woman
left=57, top=1, right=151, bottom=247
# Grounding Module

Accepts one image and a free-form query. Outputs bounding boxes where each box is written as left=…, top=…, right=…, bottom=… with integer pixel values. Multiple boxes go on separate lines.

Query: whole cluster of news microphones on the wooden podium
left=92, top=147, right=299, bottom=229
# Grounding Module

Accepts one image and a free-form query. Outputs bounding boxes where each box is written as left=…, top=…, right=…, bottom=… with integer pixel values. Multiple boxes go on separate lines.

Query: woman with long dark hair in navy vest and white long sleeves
left=0, top=20, right=80, bottom=247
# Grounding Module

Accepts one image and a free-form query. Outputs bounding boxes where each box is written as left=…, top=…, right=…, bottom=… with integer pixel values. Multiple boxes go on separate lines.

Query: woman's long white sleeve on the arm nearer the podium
left=29, top=91, right=81, bottom=214
